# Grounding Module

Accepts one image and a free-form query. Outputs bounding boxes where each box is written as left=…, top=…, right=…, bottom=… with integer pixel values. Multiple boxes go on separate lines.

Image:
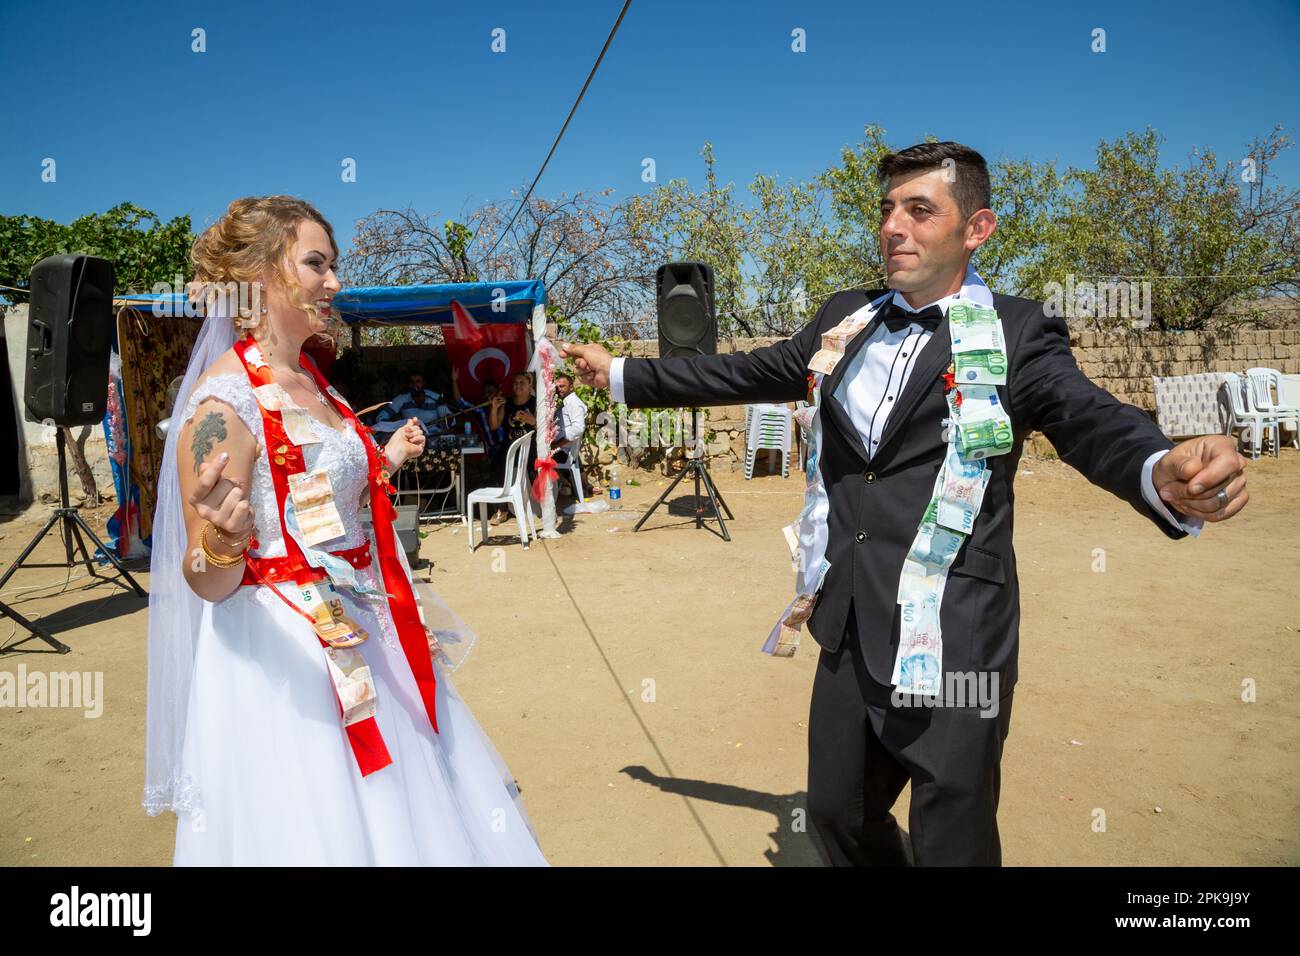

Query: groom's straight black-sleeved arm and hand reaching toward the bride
left=562, top=293, right=870, bottom=408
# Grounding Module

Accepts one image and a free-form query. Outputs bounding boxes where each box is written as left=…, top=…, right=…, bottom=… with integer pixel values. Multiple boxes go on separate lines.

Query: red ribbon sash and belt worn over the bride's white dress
left=234, top=338, right=438, bottom=777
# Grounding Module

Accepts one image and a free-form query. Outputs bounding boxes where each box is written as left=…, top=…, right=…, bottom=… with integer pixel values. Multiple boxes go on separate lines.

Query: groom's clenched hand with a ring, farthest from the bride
left=1152, top=434, right=1251, bottom=522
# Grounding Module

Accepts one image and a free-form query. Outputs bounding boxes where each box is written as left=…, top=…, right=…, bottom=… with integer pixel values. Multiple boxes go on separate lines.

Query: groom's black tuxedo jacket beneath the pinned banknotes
left=623, top=290, right=1186, bottom=695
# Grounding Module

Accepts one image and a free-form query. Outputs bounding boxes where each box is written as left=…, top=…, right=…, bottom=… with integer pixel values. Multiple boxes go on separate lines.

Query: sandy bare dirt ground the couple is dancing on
left=0, top=449, right=1300, bottom=866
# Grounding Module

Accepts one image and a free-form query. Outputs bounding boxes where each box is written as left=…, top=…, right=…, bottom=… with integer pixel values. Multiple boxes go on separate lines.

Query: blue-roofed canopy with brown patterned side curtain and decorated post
left=104, top=280, right=554, bottom=551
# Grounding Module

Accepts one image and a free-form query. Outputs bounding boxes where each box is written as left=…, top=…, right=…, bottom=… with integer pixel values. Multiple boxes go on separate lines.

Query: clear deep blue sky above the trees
left=0, top=0, right=1300, bottom=278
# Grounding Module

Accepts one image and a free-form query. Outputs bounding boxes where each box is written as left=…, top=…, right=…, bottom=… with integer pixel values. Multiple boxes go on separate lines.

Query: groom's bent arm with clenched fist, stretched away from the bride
left=1008, top=300, right=1248, bottom=537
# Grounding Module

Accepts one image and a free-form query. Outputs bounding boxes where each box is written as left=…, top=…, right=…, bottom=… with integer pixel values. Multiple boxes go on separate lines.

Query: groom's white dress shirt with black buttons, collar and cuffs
left=610, top=283, right=1204, bottom=537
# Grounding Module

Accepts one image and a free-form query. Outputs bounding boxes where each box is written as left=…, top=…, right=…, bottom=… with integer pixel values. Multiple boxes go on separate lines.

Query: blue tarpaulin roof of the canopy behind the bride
left=106, top=280, right=546, bottom=325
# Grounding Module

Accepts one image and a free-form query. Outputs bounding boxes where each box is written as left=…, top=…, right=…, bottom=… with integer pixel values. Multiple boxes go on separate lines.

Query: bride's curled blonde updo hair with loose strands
left=190, top=196, right=338, bottom=337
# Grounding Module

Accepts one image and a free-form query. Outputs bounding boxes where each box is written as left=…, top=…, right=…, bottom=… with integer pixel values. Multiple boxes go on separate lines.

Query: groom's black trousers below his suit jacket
left=809, top=610, right=1014, bottom=866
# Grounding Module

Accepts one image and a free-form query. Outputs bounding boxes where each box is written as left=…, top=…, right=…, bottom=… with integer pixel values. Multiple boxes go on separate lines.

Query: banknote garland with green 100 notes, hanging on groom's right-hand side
left=889, top=300, right=1014, bottom=697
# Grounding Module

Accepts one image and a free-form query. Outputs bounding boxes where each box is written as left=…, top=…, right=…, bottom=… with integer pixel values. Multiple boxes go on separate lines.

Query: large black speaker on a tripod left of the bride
left=23, top=255, right=113, bottom=425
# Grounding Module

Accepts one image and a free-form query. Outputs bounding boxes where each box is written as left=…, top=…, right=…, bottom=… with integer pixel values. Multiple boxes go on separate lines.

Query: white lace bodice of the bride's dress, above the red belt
left=181, top=372, right=369, bottom=558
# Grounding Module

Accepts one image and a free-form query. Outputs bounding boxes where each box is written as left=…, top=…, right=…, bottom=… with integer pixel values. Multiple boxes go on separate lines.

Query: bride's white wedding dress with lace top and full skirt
left=174, top=373, right=546, bottom=866
